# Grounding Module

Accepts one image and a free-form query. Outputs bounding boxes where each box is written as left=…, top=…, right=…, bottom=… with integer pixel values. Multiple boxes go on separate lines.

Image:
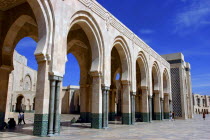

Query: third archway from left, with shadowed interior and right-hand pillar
left=109, top=36, right=134, bottom=125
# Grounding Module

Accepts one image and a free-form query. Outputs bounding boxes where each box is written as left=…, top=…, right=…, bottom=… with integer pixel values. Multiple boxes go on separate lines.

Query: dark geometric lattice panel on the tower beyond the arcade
left=171, top=68, right=182, bottom=117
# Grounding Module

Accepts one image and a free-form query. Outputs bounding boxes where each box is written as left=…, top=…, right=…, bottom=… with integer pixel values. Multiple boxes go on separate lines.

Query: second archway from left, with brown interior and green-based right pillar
left=63, top=11, right=103, bottom=128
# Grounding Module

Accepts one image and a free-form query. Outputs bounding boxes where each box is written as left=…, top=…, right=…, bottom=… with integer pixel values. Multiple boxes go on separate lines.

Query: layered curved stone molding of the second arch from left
left=66, top=11, right=104, bottom=73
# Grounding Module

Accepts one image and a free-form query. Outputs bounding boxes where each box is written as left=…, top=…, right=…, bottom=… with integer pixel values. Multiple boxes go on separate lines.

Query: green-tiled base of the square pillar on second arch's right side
left=91, top=113, right=102, bottom=129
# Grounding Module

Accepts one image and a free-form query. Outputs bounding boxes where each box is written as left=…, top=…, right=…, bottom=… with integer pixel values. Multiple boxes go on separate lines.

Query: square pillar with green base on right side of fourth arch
left=141, top=89, right=151, bottom=122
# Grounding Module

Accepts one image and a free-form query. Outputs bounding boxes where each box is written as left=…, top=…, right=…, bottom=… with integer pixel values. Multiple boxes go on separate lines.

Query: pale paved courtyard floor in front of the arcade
left=0, top=114, right=210, bottom=140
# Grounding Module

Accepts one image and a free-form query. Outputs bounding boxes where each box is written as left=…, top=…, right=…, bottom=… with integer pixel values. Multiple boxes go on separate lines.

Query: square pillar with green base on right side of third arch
left=122, top=81, right=131, bottom=125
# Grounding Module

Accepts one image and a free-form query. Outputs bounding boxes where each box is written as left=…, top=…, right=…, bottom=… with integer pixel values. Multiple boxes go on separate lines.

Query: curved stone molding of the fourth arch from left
left=136, top=51, right=149, bottom=88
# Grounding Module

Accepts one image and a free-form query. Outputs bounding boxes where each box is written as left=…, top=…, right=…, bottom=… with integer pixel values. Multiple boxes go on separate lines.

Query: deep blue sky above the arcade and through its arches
left=17, top=0, right=210, bottom=95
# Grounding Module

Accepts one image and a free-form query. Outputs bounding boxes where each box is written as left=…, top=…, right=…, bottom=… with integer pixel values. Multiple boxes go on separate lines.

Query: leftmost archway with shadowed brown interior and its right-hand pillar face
left=0, top=0, right=55, bottom=136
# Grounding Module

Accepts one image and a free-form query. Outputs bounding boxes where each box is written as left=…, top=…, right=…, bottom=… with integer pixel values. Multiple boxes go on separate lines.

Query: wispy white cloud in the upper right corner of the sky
left=175, top=0, right=210, bottom=32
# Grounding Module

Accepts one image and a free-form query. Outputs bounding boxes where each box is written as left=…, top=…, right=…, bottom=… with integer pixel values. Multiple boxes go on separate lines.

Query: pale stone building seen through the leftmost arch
left=7, top=51, right=37, bottom=112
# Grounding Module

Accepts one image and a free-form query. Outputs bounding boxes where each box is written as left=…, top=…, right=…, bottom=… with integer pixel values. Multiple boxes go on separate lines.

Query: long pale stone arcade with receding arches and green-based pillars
left=0, top=0, right=172, bottom=136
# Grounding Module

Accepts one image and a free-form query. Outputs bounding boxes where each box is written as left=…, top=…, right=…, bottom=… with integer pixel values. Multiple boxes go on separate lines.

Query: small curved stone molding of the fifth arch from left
left=151, top=61, right=161, bottom=92
